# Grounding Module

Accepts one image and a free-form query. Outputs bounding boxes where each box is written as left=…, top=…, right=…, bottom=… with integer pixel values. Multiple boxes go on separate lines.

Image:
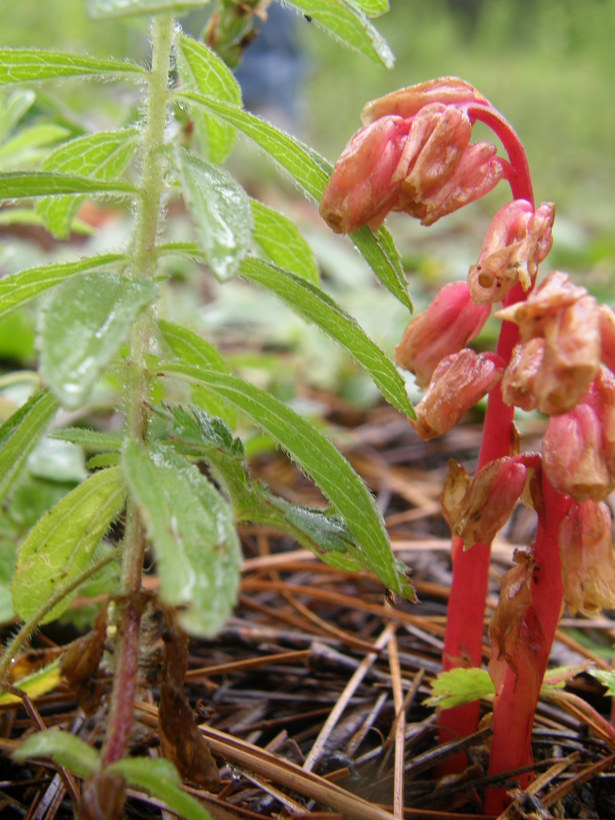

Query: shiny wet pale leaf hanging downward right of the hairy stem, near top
left=179, top=149, right=252, bottom=281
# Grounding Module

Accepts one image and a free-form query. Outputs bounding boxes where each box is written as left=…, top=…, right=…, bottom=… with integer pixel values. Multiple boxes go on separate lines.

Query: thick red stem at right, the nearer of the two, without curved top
left=485, top=472, right=571, bottom=815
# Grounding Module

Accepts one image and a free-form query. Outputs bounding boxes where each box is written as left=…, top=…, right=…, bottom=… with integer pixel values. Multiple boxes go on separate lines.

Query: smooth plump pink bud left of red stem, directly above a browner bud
left=395, top=282, right=490, bottom=388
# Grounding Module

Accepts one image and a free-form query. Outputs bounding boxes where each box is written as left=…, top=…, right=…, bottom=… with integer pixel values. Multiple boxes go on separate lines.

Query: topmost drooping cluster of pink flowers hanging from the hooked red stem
left=320, top=77, right=504, bottom=233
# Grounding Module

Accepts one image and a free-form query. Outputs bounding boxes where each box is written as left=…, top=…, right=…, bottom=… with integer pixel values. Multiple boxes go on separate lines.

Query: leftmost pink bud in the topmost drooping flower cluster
left=320, top=117, right=411, bottom=233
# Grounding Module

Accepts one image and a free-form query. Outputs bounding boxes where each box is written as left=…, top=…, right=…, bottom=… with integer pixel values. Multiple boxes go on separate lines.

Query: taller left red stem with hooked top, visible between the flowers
left=439, top=104, right=534, bottom=774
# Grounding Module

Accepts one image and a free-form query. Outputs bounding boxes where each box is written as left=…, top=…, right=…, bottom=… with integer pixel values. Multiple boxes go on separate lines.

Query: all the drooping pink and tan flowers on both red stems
left=320, top=77, right=615, bottom=628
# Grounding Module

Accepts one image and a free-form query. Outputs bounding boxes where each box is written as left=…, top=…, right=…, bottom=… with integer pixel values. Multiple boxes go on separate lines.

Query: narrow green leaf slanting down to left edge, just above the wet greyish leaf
left=0, top=253, right=126, bottom=319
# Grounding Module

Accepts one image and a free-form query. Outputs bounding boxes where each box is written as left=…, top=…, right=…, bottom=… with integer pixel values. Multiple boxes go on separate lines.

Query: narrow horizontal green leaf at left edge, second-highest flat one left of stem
left=0, top=171, right=138, bottom=200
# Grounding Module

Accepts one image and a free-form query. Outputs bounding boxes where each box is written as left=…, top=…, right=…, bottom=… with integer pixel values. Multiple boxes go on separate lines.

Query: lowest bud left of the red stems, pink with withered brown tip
left=440, top=457, right=527, bottom=549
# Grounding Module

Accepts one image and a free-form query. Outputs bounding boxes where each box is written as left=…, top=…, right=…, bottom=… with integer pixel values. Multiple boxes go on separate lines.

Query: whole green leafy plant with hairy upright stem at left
left=0, top=0, right=413, bottom=817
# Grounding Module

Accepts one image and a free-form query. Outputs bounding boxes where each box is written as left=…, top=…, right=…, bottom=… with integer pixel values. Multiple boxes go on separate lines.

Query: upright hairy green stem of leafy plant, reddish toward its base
left=102, top=15, right=174, bottom=765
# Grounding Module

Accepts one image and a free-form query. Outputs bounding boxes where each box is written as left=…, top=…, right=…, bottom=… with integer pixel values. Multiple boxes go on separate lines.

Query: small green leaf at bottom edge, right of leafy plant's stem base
left=106, top=757, right=212, bottom=820
